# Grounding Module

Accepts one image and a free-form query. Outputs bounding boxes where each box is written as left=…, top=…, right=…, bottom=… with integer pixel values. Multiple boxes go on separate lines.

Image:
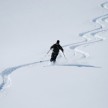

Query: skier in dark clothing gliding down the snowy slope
left=50, top=40, right=64, bottom=63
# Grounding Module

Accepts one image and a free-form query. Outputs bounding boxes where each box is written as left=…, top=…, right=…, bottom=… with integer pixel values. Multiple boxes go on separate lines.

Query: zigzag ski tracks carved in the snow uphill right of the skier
left=64, top=2, right=108, bottom=59
